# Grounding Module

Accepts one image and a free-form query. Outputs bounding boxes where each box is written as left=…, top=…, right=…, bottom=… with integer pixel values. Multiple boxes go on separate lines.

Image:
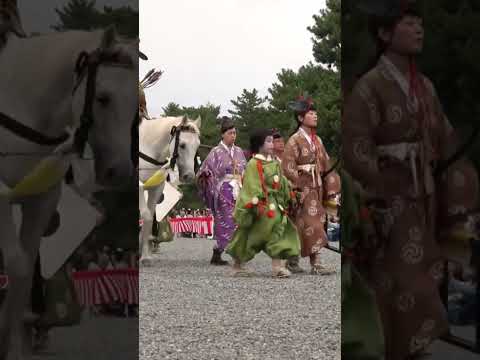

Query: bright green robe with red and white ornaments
left=227, top=154, right=300, bottom=263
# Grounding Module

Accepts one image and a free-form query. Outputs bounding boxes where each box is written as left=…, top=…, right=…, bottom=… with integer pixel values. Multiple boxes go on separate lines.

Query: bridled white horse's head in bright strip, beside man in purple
left=169, top=116, right=202, bottom=183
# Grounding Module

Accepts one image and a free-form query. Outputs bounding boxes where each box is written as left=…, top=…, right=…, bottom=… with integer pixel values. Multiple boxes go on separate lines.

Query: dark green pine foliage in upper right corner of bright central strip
left=308, top=0, right=342, bottom=69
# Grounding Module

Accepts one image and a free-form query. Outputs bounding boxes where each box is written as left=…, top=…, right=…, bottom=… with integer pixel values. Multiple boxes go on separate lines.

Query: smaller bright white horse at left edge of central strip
left=138, top=116, right=201, bottom=265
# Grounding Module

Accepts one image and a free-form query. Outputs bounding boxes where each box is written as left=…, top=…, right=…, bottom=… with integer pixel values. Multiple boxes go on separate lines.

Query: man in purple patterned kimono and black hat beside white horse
left=197, top=117, right=247, bottom=265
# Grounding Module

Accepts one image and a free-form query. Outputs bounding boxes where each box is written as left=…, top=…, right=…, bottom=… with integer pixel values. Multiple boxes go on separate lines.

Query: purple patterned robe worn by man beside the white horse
left=197, top=143, right=247, bottom=251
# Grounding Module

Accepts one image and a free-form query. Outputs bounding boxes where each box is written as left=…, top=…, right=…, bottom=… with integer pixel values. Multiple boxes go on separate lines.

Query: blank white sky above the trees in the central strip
left=140, top=0, right=325, bottom=116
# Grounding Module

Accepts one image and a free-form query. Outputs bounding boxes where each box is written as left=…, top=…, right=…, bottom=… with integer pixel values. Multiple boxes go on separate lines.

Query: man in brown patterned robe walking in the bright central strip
left=282, top=97, right=340, bottom=275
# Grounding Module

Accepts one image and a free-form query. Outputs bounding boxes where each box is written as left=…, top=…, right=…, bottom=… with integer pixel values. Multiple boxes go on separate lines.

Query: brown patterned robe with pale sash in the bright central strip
left=282, top=128, right=340, bottom=257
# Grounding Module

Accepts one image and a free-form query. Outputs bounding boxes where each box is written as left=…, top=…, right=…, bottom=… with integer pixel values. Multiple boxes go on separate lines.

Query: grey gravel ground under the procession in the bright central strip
left=139, top=238, right=341, bottom=360
